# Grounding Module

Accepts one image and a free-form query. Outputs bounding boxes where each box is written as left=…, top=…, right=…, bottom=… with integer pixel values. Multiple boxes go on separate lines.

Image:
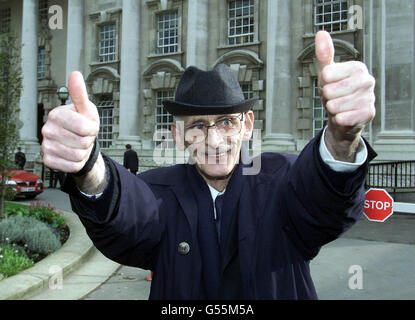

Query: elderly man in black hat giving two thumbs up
left=42, top=32, right=375, bottom=299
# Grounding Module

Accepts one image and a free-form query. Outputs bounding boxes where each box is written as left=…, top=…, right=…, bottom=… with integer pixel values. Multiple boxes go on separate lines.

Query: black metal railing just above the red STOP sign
left=366, top=160, right=415, bottom=193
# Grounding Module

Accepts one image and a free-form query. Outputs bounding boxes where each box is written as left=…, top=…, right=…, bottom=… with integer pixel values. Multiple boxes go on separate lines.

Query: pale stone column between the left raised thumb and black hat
left=117, top=0, right=141, bottom=148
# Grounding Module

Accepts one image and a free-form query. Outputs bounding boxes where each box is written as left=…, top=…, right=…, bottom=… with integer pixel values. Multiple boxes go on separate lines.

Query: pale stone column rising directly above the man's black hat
left=186, top=0, right=209, bottom=70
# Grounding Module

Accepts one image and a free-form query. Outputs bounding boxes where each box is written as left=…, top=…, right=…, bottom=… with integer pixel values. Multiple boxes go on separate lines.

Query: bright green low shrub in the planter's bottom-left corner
left=0, top=245, right=35, bottom=280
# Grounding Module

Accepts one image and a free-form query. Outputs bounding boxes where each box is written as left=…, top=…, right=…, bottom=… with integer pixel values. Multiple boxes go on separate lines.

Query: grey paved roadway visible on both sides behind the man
left=22, top=189, right=415, bottom=300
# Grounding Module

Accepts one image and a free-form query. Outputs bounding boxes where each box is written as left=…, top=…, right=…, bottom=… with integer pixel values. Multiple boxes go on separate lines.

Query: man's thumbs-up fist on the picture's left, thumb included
left=42, top=71, right=99, bottom=173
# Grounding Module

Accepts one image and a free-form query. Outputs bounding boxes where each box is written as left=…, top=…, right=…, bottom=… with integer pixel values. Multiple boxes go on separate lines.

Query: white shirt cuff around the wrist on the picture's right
left=319, top=127, right=368, bottom=172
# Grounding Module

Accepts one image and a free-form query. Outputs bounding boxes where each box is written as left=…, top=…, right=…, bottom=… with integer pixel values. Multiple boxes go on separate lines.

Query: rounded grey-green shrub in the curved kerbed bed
left=0, top=215, right=61, bottom=254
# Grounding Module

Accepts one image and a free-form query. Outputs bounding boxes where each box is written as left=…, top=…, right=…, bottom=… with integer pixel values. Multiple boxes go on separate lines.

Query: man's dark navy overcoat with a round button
left=64, top=137, right=374, bottom=299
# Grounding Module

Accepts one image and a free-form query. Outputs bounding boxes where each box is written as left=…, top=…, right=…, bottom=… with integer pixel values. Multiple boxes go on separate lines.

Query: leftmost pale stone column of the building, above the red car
left=20, top=0, right=40, bottom=161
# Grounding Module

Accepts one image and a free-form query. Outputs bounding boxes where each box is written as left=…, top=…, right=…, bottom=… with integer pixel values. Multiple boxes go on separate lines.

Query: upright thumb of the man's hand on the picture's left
left=68, top=71, right=94, bottom=116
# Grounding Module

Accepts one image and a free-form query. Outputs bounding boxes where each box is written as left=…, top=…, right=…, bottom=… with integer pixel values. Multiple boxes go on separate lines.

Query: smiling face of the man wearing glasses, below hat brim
left=172, top=111, right=254, bottom=179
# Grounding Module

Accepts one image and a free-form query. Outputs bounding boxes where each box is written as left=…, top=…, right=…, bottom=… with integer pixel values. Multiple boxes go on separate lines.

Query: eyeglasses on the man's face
left=184, top=113, right=244, bottom=143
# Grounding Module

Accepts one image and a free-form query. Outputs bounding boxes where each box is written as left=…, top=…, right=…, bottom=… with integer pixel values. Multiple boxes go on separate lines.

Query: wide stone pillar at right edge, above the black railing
left=374, top=0, right=415, bottom=161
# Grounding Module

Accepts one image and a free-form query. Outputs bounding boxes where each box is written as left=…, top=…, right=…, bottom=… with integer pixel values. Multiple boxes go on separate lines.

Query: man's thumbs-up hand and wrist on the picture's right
left=315, top=31, right=376, bottom=162
